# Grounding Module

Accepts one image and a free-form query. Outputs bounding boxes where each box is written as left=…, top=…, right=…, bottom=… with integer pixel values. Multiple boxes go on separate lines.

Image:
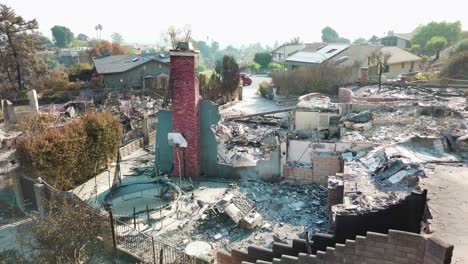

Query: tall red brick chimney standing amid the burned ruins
left=170, top=42, right=200, bottom=177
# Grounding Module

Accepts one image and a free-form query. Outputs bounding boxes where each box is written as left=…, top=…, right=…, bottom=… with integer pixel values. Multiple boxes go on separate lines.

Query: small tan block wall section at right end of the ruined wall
left=312, top=153, right=344, bottom=180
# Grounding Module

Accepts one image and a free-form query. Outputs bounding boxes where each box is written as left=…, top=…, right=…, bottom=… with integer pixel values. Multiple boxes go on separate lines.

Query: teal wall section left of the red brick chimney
left=155, top=110, right=173, bottom=174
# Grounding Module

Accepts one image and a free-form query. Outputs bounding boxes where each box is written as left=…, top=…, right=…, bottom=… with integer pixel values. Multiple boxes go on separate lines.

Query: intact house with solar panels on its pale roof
left=284, top=43, right=422, bottom=79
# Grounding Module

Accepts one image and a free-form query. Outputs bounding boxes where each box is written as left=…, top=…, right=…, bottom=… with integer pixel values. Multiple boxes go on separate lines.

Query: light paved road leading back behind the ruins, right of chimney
left=222, top=76, right=288, bottom=116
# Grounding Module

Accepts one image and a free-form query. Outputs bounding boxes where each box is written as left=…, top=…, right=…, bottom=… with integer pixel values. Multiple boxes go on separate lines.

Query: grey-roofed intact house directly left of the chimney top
left=94, top=53, right=170, bottom=89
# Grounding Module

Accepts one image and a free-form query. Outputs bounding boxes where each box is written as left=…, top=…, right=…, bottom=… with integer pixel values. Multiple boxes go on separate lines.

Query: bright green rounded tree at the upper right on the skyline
left=411, top=21, right=463, bottom=53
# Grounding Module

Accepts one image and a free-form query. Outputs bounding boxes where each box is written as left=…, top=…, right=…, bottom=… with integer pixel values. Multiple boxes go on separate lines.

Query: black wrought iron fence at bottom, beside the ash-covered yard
left=114, top=219, right=209, bottom=264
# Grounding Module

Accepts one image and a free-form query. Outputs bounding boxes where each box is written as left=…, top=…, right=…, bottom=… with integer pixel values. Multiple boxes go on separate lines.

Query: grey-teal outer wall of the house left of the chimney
left=104, top=61, right=169, bottom=89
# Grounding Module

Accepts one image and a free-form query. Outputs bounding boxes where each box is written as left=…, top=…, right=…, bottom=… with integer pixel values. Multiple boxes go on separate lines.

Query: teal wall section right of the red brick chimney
left=200, top=100, right=223, bottom=177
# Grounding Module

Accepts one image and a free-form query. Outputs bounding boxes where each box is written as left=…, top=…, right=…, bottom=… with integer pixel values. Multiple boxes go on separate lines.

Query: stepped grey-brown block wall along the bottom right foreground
left=217, top=230, right=453, bottom=264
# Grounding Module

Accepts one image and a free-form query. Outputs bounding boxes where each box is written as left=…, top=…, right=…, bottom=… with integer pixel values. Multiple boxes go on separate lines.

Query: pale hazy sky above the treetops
left=0, top=0, right=468, bottom=46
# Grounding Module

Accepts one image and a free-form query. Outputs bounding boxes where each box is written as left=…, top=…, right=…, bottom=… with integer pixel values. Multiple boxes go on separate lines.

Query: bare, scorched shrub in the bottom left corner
left=12, top=199, right=106, bottom=263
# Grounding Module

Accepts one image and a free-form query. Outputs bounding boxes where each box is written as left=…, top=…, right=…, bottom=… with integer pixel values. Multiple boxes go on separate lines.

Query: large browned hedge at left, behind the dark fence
left=16, top=113, right=123, bottom=190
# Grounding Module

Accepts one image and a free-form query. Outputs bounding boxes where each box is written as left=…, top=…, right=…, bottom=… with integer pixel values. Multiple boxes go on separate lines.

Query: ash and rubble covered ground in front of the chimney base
left=125, top=163, right=328, bottom=258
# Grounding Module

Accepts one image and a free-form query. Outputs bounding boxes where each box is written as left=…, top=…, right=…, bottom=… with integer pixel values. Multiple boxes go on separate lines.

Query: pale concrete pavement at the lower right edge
left=421, top=165, right=468, bottom=264
